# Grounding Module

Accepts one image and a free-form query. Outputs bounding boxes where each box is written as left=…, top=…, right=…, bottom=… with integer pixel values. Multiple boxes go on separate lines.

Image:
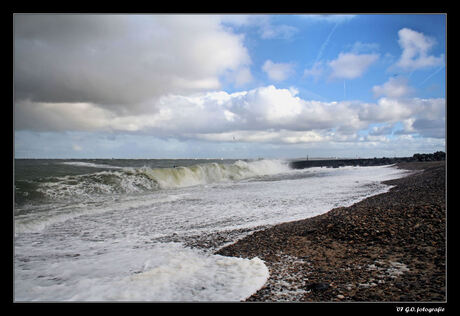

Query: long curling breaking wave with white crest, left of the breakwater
left=37, top=160, right=290, bottom=199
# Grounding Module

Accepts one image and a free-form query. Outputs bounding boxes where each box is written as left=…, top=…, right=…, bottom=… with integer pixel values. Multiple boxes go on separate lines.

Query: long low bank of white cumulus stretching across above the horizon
left=15, top=86, right=445, bottom=143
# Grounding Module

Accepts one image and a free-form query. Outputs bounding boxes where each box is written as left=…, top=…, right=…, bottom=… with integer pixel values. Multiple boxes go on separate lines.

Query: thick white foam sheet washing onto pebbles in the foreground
left=15, top=240, right=269, bottom=301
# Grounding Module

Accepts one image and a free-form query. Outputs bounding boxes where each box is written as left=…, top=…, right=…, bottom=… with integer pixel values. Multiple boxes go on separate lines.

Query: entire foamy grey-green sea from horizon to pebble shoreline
left=13, top=159, right=406, bottom=302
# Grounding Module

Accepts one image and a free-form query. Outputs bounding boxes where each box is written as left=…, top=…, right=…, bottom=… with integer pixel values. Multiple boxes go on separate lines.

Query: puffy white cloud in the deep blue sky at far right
left=396, top=28, right=444, bottom=71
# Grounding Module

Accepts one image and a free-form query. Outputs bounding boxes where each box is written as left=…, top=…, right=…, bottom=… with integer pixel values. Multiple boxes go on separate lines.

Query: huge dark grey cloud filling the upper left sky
left=14, top=14, right=251, bottom=112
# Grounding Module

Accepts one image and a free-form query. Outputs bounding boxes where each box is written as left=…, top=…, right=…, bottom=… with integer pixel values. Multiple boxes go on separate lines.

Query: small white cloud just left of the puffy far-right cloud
left=329, top=53, right=379, bottom=79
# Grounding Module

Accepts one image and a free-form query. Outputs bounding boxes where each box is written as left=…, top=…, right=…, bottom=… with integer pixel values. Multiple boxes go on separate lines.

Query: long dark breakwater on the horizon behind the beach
left=289, top=151, right=446, bottom=169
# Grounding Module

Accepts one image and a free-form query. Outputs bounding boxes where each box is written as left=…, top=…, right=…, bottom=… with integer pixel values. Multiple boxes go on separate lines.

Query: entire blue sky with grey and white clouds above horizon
left=13, top=14, right=446, bottom=158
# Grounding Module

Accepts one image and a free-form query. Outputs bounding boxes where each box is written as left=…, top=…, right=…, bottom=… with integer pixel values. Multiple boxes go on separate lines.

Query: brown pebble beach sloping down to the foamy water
left=217, top=161, right=446, bottom=302
